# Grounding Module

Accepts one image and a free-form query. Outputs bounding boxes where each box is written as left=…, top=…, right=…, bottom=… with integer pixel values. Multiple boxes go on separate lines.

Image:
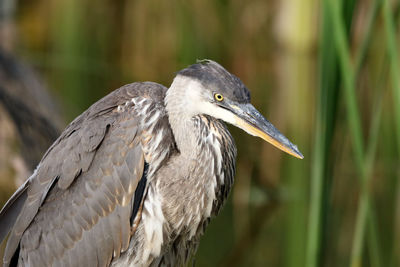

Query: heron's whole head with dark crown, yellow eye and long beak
left=167, top=60, right=303, bottom=158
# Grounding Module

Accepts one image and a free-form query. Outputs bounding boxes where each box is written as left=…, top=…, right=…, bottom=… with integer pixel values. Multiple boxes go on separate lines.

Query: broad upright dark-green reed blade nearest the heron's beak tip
left=306, top=1, right=338, bottom=267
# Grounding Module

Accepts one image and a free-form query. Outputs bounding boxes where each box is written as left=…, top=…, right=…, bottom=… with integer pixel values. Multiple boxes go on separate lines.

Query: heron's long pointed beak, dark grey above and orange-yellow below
left=228, top=103, right=304, bottom=159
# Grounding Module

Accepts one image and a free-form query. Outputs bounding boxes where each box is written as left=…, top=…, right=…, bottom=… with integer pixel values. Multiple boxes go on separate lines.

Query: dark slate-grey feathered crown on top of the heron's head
left=178, top=59, right=250, bottom=103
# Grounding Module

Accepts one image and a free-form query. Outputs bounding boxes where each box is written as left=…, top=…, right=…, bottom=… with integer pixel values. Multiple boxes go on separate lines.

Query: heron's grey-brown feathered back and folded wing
left=0, top=82, right=174, bottom=266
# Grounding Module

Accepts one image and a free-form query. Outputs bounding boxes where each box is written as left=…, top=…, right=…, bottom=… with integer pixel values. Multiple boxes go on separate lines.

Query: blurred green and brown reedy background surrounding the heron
left=0, top=0, right=400, bottom=267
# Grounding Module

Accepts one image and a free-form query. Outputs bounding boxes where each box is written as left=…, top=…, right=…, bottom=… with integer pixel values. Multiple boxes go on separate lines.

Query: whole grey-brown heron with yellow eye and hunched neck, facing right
left=0, top=60, right=303, bottom=266
